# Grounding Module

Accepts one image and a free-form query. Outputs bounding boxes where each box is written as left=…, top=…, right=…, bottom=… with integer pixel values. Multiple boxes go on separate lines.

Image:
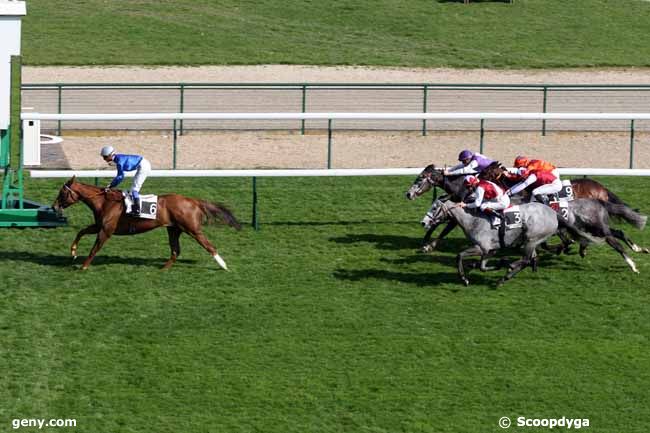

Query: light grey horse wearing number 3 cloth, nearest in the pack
left=422, top=200, right=599, bottom=286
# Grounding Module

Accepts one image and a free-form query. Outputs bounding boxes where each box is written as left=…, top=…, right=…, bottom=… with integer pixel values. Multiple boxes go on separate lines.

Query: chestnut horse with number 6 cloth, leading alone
left=52, top=176, right=241, bottom=270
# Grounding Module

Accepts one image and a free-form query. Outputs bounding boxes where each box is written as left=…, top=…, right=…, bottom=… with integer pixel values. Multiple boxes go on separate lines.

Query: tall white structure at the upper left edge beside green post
left=0, top=0, right=27, bottom=129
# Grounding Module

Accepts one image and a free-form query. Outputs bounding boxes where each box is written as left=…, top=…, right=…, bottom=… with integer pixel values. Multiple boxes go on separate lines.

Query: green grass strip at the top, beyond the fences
left=23, top=0, right=650, bottom=68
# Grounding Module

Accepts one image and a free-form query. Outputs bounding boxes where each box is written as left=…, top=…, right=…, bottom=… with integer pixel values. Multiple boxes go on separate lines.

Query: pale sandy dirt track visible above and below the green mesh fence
left=23, top=65, right=650, bottom=169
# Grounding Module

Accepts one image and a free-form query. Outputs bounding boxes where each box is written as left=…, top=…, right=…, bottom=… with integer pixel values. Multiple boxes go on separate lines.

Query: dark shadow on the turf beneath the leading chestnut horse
left=0, top=251, right=197, bottom=268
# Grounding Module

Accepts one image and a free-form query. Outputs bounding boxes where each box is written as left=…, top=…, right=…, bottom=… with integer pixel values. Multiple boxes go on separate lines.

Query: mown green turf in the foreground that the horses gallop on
left=0, top=177, right=650, bottom=433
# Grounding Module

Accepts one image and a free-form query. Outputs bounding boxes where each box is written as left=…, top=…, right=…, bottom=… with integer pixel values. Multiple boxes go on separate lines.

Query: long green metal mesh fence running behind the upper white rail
left=22, top=83, right=650, bottom=135
